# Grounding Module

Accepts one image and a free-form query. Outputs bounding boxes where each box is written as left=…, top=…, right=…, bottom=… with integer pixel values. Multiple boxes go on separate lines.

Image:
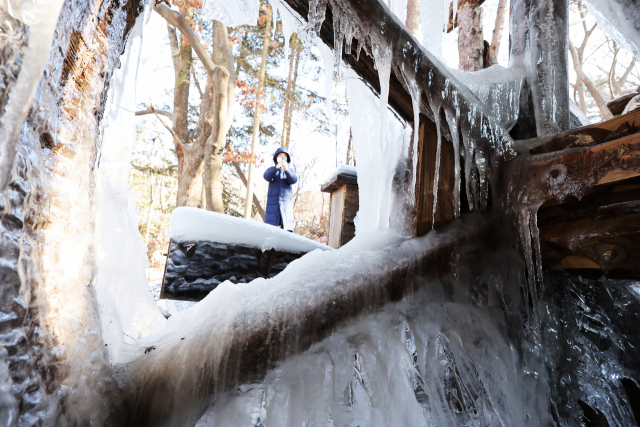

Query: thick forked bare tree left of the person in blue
left=137, top=1, right=235, bottom=212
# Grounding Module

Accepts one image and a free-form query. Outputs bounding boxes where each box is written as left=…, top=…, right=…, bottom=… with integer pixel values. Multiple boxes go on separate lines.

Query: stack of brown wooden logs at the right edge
left=505, top=110, right=640, bottom=270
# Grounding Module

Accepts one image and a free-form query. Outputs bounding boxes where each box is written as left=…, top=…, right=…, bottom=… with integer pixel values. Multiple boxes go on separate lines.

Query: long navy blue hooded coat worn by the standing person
left=264, top=148, right=298, bottom=231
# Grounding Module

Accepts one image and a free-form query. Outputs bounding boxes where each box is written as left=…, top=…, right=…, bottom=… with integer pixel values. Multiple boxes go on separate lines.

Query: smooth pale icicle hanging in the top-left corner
left=0, top=0, right=63, bottom=191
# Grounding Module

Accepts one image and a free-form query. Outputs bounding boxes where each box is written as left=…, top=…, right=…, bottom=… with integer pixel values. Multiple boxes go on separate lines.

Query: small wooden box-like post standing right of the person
left=320, top=168, right=360, bottom=249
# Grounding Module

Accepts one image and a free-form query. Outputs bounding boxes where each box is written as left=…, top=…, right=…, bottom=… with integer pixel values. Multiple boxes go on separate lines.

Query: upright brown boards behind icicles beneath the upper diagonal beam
left=416, top=120, right=454, bottom=236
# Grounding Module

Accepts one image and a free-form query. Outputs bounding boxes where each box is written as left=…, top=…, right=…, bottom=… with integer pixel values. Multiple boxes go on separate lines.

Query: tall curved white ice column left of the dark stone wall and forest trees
left=94, top=15, right=166, bottom=363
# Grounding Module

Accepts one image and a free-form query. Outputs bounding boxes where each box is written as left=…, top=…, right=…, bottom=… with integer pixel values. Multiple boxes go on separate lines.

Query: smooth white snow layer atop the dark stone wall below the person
left=168, top=207, right=333, bottom=253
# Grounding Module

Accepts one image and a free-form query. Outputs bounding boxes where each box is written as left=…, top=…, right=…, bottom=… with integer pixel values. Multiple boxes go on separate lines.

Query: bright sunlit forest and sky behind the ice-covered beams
left=130, top=0, right=640, bottom=282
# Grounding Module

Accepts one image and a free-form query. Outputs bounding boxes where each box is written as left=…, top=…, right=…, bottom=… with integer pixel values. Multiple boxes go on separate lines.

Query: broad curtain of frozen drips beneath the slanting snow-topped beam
left=198, top=251, right=553, bottom=427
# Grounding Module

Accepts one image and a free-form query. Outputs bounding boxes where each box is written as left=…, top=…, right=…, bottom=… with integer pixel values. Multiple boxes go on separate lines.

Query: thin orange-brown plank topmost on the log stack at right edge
left=527, top=109, right=640, bottom=154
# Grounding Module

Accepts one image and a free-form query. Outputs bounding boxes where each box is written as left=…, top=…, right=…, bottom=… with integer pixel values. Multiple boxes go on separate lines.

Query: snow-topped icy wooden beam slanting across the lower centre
left=109, top=214, right=498, bottom=426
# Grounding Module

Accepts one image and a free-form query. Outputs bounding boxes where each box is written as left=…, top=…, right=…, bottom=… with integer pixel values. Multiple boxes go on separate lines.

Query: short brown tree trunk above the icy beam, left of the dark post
left=457, top=0, right=484, bottom=71
